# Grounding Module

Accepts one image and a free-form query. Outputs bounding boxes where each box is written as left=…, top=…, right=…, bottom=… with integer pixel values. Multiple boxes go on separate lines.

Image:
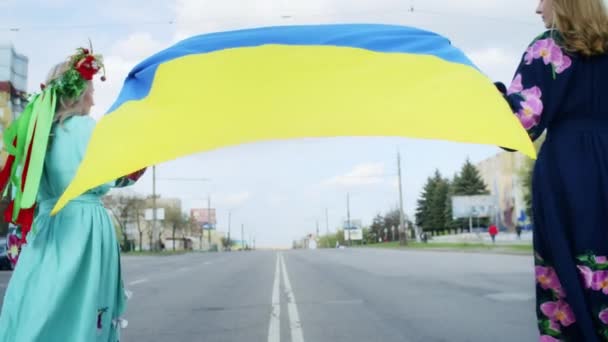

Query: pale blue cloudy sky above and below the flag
left=0, top=0, right=543, bottom=247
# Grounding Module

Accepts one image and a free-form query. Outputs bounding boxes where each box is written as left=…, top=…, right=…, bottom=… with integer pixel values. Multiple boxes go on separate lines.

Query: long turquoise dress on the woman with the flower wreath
left=0, top=116, right=141, bottom=342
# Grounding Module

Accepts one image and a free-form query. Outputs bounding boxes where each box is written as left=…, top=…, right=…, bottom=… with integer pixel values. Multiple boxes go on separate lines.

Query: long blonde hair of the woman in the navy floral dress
left=553, top=0, right=608, bottom=56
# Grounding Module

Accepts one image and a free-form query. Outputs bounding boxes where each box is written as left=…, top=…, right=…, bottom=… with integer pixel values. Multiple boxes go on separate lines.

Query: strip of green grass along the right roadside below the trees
left=358, top=241, right=533, bottom=254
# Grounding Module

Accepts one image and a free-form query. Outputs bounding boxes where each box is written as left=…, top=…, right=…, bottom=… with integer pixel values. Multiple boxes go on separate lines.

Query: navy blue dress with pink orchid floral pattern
left=497, top=31, right=608, bottom=342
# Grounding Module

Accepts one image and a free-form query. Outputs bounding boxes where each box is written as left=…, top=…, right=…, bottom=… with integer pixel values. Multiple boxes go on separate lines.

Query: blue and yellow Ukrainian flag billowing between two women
left=56, top=24, right=535, bottom=214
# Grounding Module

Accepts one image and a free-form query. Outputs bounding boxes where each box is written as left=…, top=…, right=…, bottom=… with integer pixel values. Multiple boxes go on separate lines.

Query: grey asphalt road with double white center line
left=0, top=249, right=538, bottom=342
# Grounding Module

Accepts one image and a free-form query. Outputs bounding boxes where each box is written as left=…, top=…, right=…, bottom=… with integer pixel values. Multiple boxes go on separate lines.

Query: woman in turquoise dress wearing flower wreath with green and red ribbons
left=0, top=48, right=143, bottom=342
